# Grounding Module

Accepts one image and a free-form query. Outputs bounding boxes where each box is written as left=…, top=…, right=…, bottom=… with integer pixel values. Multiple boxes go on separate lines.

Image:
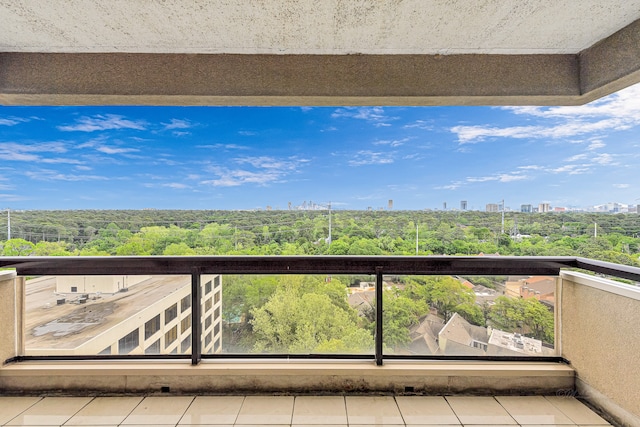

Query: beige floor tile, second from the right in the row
left=496, top=396, right=573, bottom=425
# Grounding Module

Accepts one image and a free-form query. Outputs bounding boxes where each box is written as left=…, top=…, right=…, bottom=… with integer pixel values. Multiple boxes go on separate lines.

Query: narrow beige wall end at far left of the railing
left=0, top=270, right=25, bottom=364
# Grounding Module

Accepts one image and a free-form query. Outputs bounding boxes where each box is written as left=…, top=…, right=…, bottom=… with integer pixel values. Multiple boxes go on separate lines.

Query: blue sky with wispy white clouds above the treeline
left=0, top=85, right=640, bottom=210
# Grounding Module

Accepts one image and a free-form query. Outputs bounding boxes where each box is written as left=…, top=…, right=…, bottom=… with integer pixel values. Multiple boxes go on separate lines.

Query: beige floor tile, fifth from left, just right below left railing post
left=179, top=396, right=244, bottom=426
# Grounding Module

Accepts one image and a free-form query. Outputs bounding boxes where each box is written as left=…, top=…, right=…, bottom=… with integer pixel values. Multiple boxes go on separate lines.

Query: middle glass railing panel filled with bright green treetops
left=221, top=274, right=375, bottom=355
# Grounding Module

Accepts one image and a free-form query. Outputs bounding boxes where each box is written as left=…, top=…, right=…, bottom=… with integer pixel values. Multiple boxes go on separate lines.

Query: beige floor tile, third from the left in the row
left=65, top=397, right=142, bottom=426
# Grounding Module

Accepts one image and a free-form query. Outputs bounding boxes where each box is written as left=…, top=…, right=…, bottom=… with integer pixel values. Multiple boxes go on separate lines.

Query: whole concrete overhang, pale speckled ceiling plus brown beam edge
left=0, top=0, right=640, bottom=105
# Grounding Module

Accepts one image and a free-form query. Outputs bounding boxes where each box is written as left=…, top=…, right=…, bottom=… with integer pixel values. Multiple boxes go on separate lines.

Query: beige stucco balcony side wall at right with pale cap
left=560, top=272, right=640, bottom=426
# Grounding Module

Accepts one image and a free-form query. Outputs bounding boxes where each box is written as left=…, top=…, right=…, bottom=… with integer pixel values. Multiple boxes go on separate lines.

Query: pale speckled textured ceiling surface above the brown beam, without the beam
left=0, top=0, right=640, bottom=54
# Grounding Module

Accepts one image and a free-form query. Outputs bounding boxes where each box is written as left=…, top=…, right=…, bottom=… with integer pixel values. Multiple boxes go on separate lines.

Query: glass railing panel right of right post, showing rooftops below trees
left=383, top=276, right=557, bottom=357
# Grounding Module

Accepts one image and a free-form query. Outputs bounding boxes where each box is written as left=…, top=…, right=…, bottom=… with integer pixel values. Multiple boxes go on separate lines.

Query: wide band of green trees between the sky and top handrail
left=0, top=210, right=640, bottom=266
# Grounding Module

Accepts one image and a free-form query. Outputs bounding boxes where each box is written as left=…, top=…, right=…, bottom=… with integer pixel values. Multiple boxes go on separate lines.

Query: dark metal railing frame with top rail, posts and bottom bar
left=0, top=256, right=640, bottom=365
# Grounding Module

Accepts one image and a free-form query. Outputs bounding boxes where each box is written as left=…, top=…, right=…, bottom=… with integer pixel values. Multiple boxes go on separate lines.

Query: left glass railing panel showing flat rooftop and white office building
left=25, top=275, right=191, bottom=356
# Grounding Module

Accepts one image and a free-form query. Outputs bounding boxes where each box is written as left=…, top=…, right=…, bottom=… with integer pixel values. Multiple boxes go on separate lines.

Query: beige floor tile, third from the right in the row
left=446, top=396, right=517, bottom=426
